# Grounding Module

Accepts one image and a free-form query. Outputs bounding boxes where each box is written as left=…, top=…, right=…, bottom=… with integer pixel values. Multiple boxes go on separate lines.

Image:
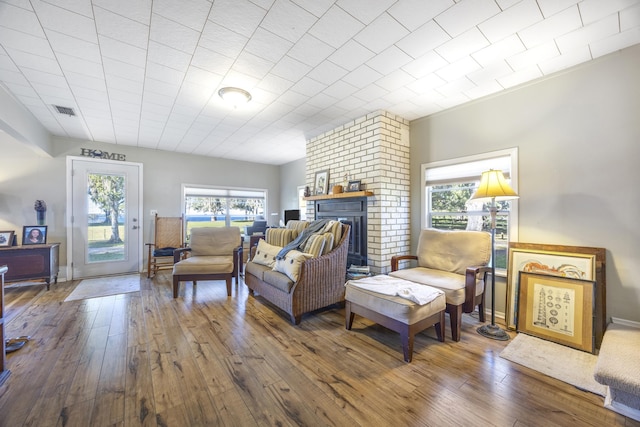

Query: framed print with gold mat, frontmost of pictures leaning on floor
left=517, top=271, right=596, bottom=353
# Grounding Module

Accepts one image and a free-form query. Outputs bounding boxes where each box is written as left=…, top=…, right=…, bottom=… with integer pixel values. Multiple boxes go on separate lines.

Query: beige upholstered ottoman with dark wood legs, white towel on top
left=345, top=275, right=446, bottom=362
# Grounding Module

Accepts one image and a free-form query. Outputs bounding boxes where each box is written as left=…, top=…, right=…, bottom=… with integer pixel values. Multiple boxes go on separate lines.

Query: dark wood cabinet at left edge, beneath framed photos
left=0, top=243, right=60, bottom=289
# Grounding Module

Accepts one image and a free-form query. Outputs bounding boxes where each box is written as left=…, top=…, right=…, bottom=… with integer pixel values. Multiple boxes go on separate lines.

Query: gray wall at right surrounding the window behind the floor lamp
left=411, top=46, right=640, bottom=321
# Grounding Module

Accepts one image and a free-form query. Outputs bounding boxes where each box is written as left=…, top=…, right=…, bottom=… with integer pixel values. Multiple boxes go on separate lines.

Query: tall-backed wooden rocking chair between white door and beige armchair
left=146, top=214, right=184, bottom=278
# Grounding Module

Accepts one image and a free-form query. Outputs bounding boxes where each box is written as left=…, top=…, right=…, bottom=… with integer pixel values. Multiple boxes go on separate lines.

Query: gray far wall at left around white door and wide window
left=0, top=132, right=281, bottom=266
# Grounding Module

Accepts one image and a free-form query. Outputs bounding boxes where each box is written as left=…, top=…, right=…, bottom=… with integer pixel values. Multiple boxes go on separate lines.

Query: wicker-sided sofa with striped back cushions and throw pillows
left=244, top=221, right=350, bottom=325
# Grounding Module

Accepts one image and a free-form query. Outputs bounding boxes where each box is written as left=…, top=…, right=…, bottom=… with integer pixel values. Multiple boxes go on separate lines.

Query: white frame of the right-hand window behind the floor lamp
left=420, top=147, right=519, bottom=276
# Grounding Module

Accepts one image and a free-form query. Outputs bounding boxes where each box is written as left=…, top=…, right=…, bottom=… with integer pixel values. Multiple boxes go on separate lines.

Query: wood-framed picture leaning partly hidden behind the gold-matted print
left=505, top=242, right=604, bottom=329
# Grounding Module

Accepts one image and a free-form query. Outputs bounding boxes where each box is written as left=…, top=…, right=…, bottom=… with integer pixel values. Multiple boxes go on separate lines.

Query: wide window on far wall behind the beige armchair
left=183, top=186, right=267, bottom=236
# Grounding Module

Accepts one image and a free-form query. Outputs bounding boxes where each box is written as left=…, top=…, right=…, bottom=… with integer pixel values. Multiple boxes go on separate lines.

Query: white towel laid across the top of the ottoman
left=347, top=275, right=444, bottom=305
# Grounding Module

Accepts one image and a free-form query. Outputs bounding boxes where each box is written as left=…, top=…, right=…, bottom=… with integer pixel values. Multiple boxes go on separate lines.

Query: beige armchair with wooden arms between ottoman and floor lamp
left=389, top=228, right=491, bottom=341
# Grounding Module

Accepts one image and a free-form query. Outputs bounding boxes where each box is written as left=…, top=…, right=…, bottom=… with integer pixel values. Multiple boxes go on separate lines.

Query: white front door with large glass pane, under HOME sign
left=67, top=157, right=142, bottom=279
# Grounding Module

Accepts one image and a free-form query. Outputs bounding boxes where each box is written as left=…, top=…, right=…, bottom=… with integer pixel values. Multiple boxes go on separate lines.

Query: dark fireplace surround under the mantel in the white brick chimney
left=314, top=197, right=367, bottom=266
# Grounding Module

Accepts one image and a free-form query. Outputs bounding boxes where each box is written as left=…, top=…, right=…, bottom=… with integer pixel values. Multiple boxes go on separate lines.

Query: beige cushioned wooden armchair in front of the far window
left=173, top=227, right=242, bottom=298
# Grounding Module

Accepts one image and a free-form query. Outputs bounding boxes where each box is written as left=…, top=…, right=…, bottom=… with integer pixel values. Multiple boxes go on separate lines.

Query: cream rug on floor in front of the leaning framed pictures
left=500, top=333, right=607, bottom=396
